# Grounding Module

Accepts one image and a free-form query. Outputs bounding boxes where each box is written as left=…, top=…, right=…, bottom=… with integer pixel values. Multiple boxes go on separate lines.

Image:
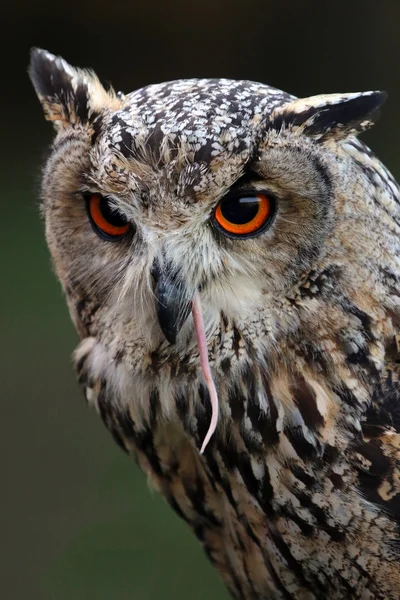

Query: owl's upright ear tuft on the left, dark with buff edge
left=28, top=48, right=120, bottom=129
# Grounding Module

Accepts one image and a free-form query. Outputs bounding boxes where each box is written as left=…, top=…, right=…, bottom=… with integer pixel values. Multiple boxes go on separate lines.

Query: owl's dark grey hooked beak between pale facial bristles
left=151, top=259, right=192, bottom=344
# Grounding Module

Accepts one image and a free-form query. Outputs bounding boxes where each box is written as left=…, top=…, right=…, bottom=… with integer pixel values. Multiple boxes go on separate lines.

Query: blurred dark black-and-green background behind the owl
left=0, top=0, right=400, bottom=600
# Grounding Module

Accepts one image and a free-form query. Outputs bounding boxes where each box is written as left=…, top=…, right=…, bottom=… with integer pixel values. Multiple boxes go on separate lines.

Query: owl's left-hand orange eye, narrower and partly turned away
left=86, top=194, right=132, bottom=241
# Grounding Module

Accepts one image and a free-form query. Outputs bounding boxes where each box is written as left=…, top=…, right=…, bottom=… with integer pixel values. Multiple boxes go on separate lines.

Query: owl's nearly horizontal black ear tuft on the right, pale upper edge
left=270, top=92, right=387, bottom=139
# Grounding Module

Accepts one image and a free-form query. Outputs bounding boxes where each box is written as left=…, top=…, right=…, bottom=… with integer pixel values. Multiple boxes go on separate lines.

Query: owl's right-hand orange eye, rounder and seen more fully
left=214, top=193, right=275, bottom=238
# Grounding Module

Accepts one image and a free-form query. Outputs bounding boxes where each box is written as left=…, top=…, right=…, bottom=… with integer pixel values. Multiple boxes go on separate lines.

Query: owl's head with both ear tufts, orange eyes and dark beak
left=31, top=51, right=384, bottom=378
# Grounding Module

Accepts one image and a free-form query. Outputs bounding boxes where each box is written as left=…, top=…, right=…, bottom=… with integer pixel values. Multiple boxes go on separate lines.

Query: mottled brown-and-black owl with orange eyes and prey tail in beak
left=29, top=49, right=400, bottom=600
